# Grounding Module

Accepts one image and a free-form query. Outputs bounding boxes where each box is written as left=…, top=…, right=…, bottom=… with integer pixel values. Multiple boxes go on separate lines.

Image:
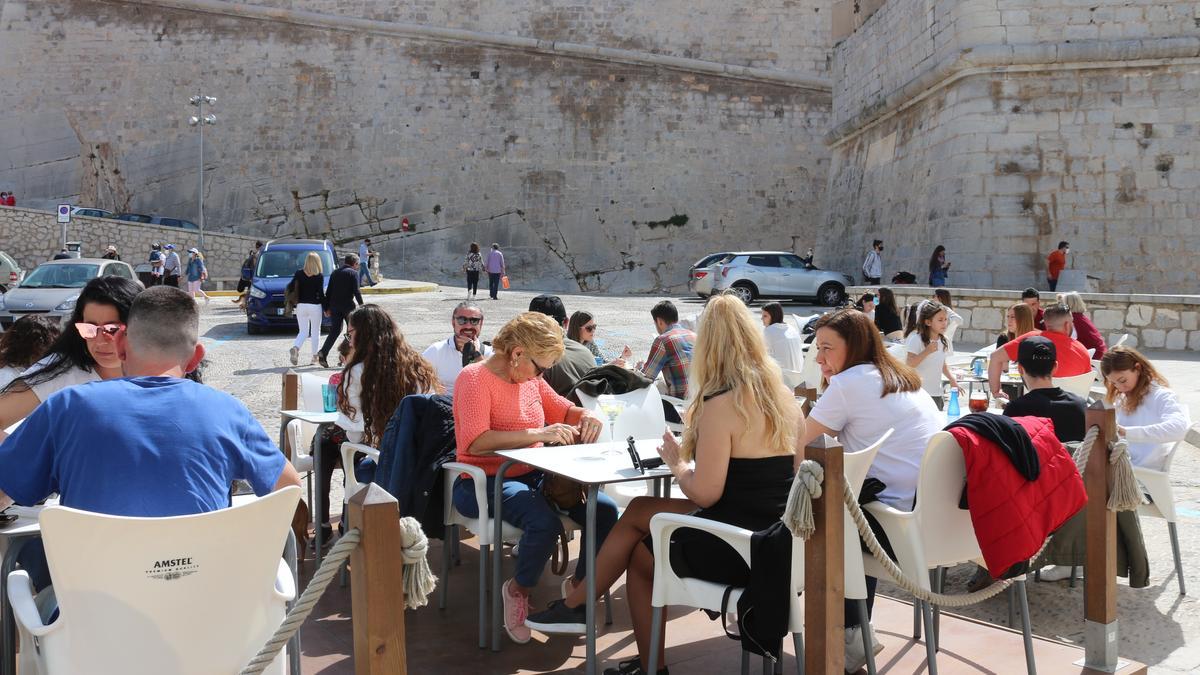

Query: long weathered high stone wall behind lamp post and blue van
left=0, top=0, right=830, bottom=291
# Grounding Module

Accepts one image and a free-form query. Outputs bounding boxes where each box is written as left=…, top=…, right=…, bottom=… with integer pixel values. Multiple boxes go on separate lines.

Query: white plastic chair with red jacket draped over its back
left=863, top=431, right=1036, bottom=675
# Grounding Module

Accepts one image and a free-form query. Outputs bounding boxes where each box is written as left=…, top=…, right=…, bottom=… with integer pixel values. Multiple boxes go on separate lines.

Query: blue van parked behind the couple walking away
left=246, top=239, right=337, bottom=335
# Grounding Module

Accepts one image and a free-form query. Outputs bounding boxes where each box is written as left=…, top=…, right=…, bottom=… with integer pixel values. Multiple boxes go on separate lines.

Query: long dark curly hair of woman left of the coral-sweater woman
left=337, top=304, right=442, bottom=446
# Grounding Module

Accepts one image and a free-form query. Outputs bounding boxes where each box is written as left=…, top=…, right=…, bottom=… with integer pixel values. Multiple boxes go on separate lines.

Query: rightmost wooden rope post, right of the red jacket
left=1084, top=401, right=1118, bottom=673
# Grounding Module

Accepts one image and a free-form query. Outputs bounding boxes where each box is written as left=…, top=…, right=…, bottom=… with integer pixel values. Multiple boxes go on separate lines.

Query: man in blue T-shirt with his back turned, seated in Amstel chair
left=0, top=285, right=300, bottom=589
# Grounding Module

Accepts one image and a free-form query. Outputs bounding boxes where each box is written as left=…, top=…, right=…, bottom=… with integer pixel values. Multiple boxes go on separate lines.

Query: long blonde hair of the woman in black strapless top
left=680, top=294, right=799, bottom=460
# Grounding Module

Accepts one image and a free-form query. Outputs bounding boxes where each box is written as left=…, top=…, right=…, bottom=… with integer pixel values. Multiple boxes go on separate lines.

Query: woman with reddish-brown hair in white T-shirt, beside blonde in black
left=800, top=310, right=946, bottom=673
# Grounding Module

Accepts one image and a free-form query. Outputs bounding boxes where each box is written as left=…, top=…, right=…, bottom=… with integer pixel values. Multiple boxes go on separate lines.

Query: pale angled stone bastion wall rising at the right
left=818, top=0, right=1200, bottom=293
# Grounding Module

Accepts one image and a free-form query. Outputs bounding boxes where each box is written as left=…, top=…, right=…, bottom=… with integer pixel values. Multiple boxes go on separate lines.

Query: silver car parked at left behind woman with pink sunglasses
left=0, top=258, right=133, bottom=329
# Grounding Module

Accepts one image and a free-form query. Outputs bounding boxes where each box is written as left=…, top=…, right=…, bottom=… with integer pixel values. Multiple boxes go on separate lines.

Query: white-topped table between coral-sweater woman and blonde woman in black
left=492, top=438, right=671, bottom=675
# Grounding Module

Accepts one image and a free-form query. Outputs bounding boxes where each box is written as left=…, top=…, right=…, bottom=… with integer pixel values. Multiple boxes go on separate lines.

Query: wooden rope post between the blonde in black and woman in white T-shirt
left=804, top=436, right=846, bottom=675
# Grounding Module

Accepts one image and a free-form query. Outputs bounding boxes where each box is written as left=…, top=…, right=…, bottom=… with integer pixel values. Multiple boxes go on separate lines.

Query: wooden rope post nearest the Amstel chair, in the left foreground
left=347, top=483, right=408, bottom=675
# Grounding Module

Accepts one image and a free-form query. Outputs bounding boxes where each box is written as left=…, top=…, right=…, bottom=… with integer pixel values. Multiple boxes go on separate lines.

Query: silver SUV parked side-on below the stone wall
left=710, top=251, right=854, bottom=306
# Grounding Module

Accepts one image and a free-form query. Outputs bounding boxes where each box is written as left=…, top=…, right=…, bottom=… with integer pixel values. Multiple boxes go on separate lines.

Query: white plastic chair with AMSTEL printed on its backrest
left=7, top=488, right=300, bottom=675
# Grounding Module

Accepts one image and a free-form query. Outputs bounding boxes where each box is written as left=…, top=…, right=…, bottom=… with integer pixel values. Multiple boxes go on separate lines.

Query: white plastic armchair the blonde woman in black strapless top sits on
left=649, top=429, right=893, bottom=675
